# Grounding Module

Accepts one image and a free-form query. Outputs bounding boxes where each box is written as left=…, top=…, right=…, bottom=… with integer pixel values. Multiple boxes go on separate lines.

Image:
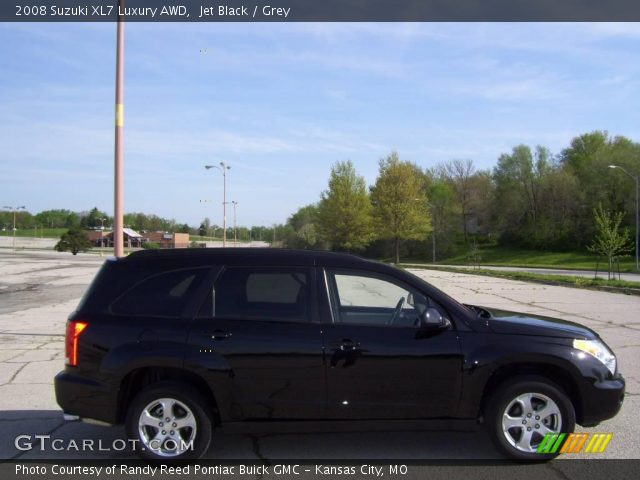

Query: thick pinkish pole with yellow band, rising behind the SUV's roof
left=113, top=0, right=124, bottom=257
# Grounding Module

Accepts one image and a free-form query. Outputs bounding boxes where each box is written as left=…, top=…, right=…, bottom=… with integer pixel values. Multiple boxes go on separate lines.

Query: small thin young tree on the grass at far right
left=587, top=205, right=633, bottom=280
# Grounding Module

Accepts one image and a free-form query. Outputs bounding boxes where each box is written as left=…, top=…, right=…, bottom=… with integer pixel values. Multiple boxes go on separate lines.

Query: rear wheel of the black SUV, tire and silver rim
left=126, top=381, right=213, bottom=462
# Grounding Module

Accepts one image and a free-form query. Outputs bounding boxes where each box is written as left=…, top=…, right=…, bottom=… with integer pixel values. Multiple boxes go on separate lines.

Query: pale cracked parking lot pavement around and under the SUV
left=0, top=251, right=640, bottom=460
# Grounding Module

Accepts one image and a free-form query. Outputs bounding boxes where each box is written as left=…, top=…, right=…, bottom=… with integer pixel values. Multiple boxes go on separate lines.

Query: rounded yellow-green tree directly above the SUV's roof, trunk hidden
left=317, top=161, right=374, bottom=251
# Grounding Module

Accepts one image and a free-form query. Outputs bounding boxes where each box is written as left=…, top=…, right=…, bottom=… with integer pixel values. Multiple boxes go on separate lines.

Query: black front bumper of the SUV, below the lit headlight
left=578, top=375, right=625, bottom=427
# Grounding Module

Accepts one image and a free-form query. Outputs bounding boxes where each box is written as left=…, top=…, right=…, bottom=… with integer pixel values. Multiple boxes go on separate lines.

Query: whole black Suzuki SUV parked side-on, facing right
left=55, top=248, right=625, bottom=460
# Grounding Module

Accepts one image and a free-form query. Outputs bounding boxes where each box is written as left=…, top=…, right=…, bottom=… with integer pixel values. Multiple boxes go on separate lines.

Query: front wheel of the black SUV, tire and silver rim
left=485, top=377, right=576, bottom=461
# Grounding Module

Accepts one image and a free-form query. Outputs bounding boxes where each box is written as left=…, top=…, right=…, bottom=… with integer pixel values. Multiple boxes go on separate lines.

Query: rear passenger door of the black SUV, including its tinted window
left=185, top=266, right=326, bottom=420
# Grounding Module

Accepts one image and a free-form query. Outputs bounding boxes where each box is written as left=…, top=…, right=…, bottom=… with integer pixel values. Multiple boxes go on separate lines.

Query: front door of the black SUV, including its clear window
left=324, top=268, right=462, bottom=418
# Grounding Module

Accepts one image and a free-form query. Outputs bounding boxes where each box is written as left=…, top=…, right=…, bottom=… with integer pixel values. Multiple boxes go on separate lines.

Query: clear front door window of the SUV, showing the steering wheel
left=327, top=270, right=428, bottom=327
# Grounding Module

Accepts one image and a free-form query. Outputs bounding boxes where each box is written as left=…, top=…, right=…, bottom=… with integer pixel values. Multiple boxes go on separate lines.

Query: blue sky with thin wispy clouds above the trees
left=0, top=23, right=640, bottom=226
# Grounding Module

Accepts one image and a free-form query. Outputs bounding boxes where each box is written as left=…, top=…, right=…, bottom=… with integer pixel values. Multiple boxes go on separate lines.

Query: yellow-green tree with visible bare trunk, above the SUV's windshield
left=371, top=152, right=431, bottom=263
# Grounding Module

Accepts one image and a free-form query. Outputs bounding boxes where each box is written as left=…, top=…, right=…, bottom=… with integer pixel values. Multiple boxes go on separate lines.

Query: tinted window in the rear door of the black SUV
left=214, top=267, right=311, bottom=321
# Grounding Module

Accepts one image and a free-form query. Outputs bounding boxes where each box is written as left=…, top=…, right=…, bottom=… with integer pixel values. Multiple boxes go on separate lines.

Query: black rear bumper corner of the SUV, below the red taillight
left=53, top=371, right=118, bottom=424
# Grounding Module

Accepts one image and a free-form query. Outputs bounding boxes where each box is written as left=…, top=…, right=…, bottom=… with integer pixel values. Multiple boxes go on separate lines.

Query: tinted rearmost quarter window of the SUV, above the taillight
left=111, top=269, right=205, bottom=317
